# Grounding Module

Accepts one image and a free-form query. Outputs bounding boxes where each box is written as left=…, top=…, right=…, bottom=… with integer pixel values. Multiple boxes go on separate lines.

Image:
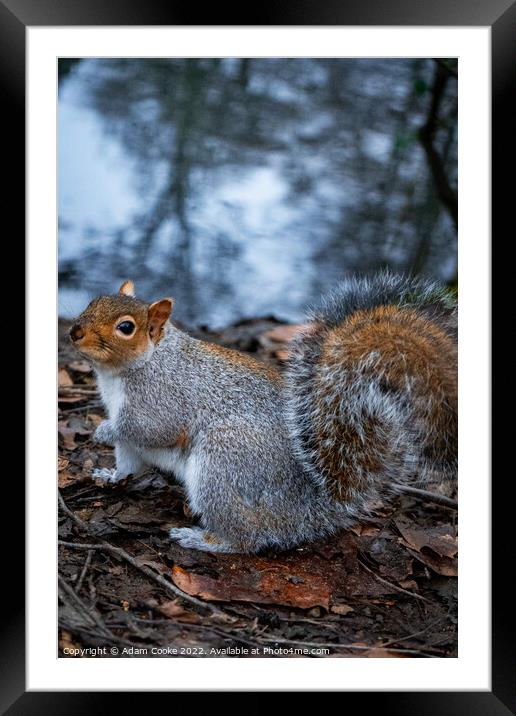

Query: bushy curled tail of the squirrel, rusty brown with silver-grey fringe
left=285, top=273, right=457, bottom=512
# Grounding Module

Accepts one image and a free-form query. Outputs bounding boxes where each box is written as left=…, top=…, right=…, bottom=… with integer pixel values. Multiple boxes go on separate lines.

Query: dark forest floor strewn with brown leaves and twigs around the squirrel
left=58, top=318, right=457, bottom=658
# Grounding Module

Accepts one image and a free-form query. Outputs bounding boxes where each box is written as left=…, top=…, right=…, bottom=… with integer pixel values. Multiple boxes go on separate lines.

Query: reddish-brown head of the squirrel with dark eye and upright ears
left=70, top=281, right=174, bottom=368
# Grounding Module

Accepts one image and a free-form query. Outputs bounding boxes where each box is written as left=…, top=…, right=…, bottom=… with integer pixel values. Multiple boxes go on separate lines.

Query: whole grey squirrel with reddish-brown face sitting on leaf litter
left=70, top=272, right=457, bottom=553
